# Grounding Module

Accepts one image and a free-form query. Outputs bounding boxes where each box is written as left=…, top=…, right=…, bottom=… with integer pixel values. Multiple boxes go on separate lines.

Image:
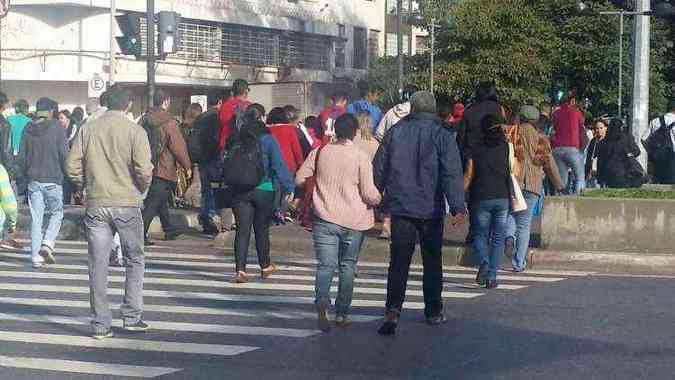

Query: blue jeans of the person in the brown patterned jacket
left=506, top=191, right=539, bottom=270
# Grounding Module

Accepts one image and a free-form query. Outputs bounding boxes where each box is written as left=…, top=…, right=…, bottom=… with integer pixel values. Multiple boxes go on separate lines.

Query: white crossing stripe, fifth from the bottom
left=0, top=283, right=476, bottom=310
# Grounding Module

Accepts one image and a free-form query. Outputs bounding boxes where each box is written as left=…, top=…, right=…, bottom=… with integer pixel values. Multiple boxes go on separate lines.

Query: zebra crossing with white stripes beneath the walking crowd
left=0, top=241, right=590, bottom=378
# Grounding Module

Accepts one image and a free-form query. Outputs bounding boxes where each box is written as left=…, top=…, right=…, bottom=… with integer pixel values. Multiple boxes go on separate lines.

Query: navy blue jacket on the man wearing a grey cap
left=373, top=113, right=465, bottom=219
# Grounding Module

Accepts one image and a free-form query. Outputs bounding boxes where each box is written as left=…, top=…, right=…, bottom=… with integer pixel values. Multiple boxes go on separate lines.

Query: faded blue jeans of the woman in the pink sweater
left=312, top=219, right=364, bottom=316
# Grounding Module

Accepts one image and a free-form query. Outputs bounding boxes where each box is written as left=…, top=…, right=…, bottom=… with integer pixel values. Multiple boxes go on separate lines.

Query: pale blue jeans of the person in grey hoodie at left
left=28, top=181, right=63, bottom=263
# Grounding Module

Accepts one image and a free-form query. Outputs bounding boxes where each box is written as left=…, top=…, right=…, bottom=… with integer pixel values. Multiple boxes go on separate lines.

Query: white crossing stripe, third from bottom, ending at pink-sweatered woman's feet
left=0, top=313, right=319, bottom=338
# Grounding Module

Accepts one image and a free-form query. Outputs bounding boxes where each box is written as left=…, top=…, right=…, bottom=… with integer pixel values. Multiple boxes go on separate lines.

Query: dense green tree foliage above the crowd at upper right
left=371, top=0, right=675, bottom=115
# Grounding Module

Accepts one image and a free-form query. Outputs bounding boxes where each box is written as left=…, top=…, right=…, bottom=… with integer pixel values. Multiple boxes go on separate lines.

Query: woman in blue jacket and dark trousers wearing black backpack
left=223, top=115, right=295, bottom=283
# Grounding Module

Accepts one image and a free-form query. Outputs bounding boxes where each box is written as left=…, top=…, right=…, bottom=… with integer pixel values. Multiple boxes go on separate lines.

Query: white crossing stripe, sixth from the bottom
left=0, top=271, right=486, bottom=298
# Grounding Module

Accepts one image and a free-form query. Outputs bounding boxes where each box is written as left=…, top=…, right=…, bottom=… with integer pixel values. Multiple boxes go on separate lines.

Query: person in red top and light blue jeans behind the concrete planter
left=551, top=93, right=587, bottom=194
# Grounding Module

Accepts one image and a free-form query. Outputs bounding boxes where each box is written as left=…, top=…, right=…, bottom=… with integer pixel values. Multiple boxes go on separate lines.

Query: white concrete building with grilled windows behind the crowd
left=0, top=0, right=385, bottom=113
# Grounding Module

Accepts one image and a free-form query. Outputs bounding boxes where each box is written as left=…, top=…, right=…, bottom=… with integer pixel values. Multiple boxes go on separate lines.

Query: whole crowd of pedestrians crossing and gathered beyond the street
left=0, top=79, right=675, bottom=339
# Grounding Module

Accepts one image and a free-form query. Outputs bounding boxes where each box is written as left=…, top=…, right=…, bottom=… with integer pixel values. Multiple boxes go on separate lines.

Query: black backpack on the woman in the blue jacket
left=222, top=137, right=265, bottom=192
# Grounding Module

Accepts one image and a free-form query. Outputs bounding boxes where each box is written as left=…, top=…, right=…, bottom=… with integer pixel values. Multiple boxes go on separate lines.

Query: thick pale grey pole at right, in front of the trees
left=631, top=0, right=650, bottom=169
